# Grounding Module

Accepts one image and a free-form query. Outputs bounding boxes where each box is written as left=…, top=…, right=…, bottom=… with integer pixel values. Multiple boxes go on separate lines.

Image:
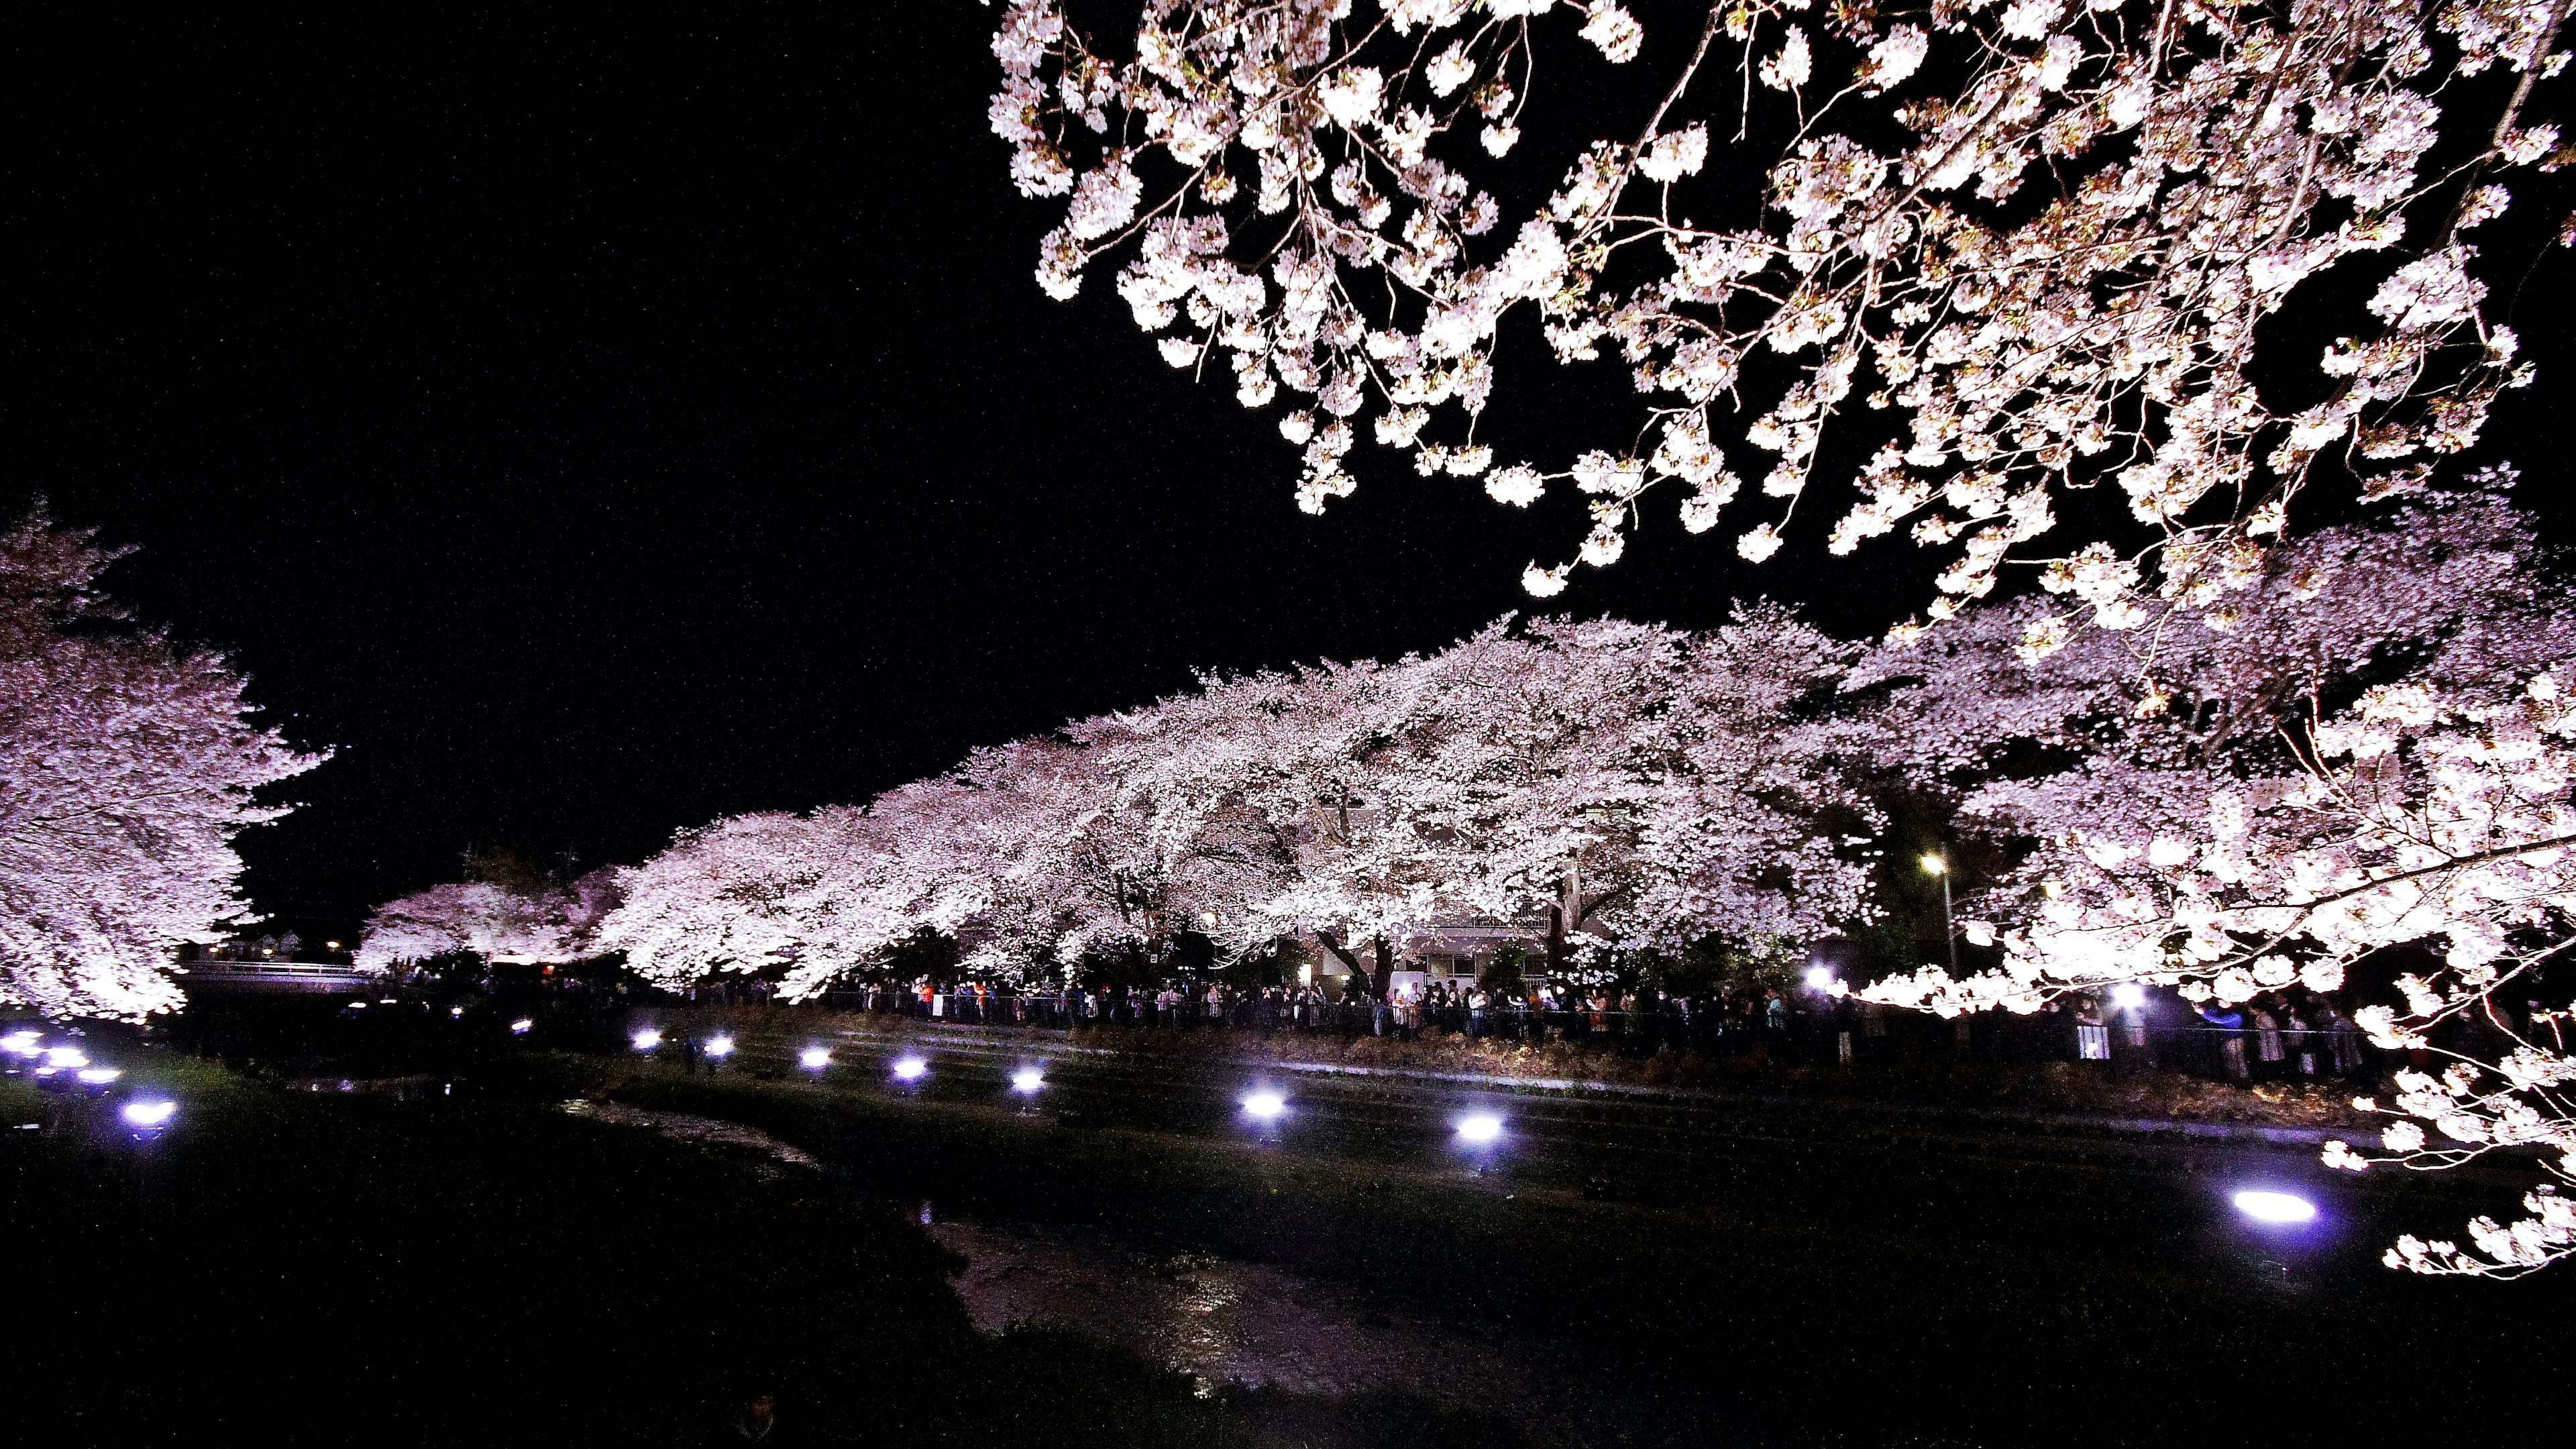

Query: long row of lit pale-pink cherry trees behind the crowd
left=600, top=606, right=1868, bottom=996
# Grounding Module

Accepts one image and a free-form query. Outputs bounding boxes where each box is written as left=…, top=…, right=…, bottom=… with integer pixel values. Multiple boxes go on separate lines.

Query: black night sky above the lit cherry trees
left=0, top=0, right=2563, bottom=915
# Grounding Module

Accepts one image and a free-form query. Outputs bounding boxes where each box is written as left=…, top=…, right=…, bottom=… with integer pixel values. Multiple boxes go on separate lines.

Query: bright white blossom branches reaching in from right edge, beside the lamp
left=1862, top=665, right=2576, bottom=1276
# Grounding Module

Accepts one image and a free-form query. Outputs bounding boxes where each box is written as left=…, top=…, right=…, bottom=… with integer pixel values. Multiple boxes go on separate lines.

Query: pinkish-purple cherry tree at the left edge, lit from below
left=0, top=511, right=325, bottom=1021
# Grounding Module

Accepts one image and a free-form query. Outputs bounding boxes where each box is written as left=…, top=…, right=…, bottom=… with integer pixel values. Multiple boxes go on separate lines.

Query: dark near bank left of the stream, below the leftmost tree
left=0, top=1057, right=1244, bottom=1444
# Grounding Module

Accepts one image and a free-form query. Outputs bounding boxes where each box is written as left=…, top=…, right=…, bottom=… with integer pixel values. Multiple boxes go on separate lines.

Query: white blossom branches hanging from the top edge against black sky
left=991, top=0, right=2568, bottom=637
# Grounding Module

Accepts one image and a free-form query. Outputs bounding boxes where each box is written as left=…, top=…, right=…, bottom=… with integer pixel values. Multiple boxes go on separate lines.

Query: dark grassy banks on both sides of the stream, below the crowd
left=0, top=1013, right=2576, bottom=1446
